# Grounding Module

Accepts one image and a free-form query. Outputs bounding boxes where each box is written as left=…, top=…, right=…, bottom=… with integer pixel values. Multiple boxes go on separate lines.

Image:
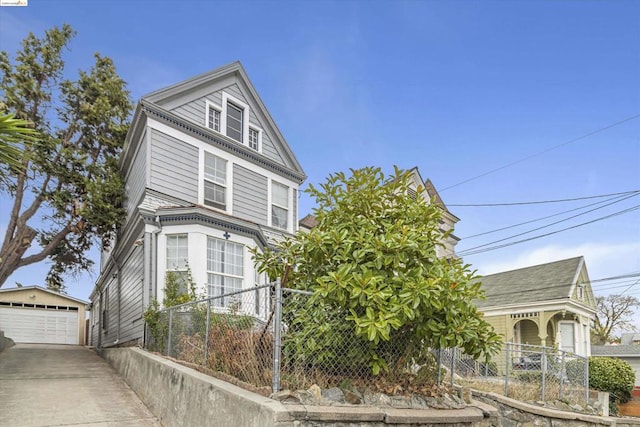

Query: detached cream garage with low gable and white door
left=0, top=286, right=87, bottom=345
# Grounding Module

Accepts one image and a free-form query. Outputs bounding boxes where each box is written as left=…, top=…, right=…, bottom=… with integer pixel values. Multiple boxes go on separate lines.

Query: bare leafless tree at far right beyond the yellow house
left=591, top=295, right=640, bottom=344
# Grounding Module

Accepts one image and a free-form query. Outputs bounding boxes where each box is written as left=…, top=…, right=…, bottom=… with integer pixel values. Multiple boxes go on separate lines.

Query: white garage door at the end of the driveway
left=0, top=307, right=78, bottom=344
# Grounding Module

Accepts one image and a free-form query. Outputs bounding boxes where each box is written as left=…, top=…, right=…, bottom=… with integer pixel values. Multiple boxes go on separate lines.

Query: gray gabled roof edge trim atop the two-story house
left=142, top=61, right=304, bottom=175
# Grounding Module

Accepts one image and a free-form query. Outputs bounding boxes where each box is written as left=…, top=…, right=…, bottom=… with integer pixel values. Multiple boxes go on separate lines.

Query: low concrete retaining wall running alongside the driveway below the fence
left=98, top=348, right=490, bottom=427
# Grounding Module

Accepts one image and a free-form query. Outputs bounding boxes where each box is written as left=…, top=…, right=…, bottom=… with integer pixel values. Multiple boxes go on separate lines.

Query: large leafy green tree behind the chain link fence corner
left=254, top=167, right=501, bottom=374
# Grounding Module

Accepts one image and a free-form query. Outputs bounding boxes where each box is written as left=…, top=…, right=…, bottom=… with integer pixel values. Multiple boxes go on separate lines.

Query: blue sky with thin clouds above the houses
left=0, top=0, right=640, bottom=324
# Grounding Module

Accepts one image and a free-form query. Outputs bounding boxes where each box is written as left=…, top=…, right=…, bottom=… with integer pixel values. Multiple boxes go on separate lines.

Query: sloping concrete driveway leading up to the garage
left=0, top=344, right=161, bottom=427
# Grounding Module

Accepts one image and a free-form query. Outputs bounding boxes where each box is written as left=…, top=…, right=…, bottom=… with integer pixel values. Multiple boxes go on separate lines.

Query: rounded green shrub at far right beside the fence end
left=589, top=357, right=636, bottom=410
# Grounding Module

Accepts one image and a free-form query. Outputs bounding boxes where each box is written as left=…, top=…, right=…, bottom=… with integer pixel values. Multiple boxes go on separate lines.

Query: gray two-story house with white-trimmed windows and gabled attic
left=90, top=62, right=305, bottom=347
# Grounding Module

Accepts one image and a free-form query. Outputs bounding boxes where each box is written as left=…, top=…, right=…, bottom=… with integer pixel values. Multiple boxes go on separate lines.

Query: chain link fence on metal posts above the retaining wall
left=147, top=282, right=589, bottom=404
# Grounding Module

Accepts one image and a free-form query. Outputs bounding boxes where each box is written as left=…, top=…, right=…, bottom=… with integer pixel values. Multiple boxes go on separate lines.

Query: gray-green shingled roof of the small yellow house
left=475, top=257, right=584, bottom=308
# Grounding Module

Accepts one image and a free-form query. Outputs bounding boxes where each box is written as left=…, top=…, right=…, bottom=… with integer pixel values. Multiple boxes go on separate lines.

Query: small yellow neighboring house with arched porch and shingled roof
left=476, top=257, right=595, bottom=356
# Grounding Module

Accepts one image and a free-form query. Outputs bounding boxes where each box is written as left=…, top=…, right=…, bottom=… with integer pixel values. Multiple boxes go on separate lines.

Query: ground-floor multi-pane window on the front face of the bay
left=207, top=237, right=244, bottom=308
